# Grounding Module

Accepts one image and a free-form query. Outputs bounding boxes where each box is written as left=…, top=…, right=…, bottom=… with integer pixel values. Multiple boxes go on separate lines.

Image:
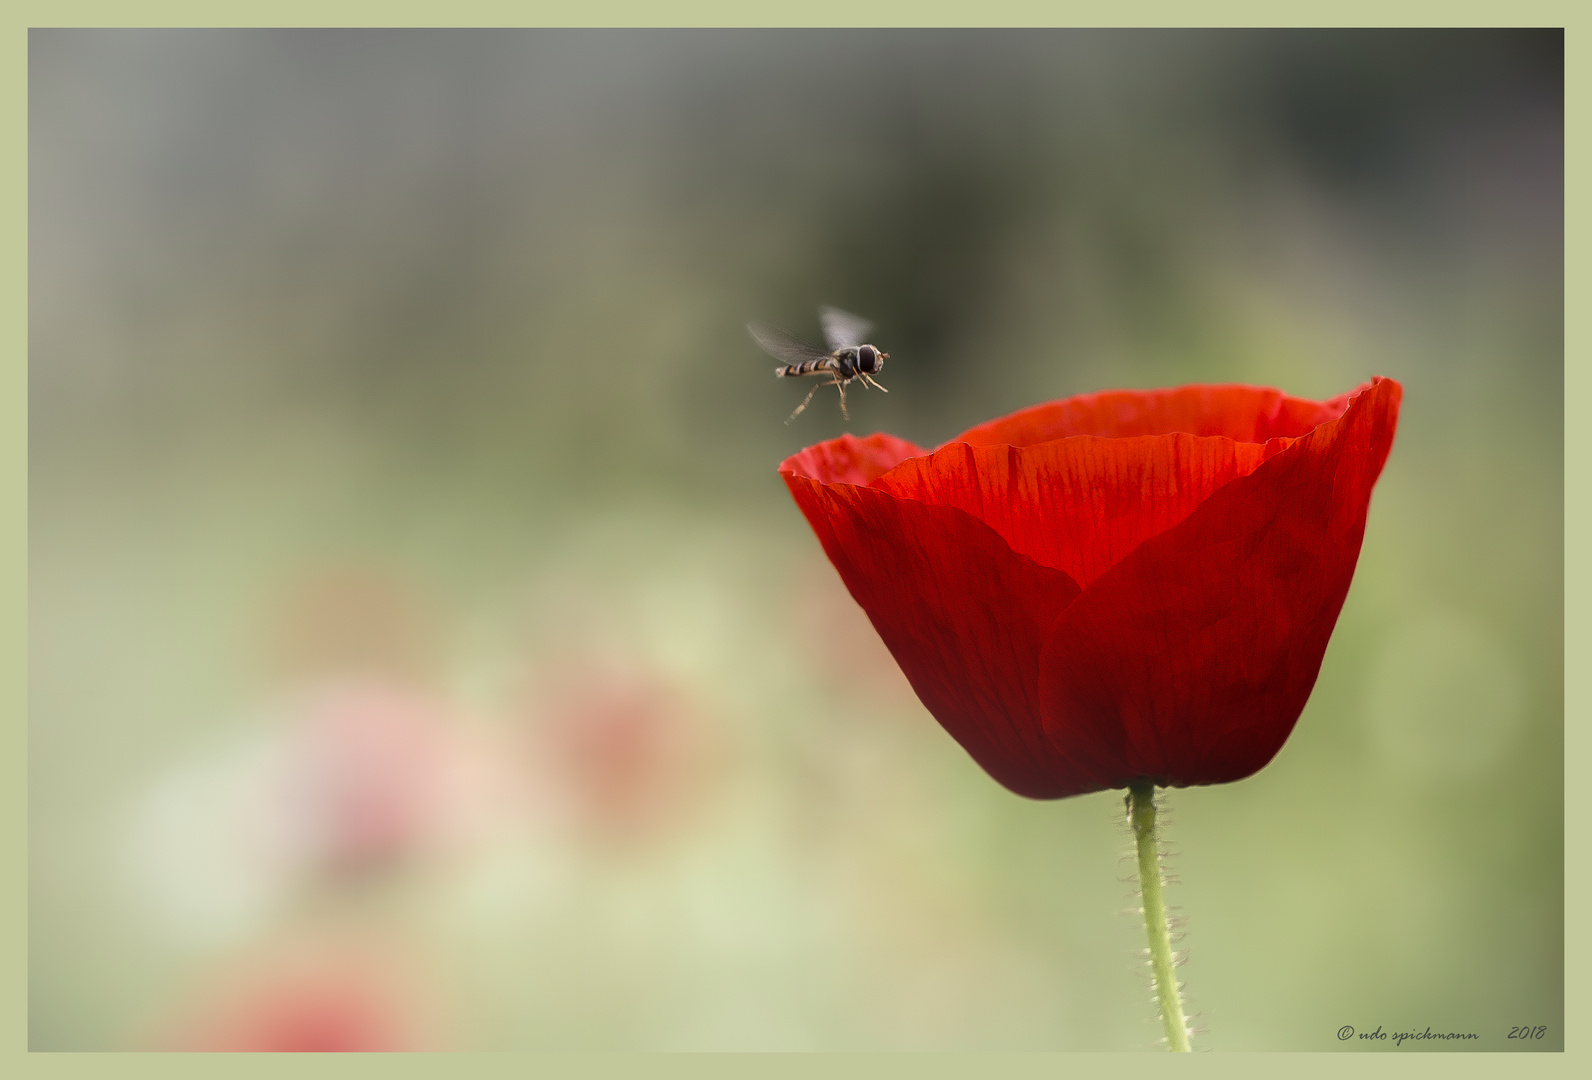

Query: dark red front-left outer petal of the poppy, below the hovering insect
left=780, top=474, right=1078, bottom=798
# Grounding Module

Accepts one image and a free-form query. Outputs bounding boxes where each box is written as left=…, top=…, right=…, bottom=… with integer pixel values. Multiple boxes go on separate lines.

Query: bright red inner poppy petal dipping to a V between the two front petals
left=871, top=433, right=1291, bottom=588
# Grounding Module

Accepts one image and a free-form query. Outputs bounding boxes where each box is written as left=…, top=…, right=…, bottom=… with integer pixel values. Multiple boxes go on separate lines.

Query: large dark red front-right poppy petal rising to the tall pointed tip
left=1040, top=379, right=1403, bottom=798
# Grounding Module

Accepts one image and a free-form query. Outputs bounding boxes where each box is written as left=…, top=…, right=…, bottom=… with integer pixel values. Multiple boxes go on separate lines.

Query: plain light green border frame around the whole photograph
left=12, top=0, right=1592, bottom=1080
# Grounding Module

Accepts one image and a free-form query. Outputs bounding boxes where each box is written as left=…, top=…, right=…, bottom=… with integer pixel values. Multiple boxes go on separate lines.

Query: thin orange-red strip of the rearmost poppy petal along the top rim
left=952, top=385, right=1353, bottom=446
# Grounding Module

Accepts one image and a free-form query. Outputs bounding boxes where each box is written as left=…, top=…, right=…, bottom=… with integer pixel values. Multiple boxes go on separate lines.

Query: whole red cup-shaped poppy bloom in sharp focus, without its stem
left=780, top=378, right=1403, bottom=798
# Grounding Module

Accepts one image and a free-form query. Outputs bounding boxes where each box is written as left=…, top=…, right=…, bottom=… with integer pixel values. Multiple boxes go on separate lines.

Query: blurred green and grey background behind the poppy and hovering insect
left=29, top=30, right=1563, bottom=1051
